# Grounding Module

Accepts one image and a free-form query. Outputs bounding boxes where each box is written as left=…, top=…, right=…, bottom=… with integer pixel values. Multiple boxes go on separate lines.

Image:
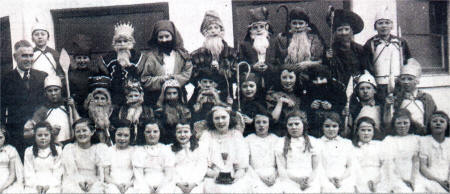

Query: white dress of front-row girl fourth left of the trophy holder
left=62, top=143, right=108, bottom=193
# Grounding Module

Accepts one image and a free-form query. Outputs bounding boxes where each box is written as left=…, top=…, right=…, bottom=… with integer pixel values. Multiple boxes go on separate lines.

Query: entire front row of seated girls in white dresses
left=0, top=106, right=450, bottom=194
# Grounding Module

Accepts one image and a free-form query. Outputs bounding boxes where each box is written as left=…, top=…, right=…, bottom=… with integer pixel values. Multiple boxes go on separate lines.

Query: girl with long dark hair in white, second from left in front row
left=24, top=121, right=64, bottom=194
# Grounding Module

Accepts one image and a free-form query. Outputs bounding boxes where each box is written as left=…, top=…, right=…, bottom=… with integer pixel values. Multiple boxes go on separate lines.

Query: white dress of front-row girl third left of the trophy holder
left=105, top=146, right=134, bottom=193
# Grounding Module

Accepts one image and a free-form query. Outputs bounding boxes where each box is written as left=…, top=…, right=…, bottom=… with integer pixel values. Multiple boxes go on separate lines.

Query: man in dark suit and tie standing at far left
left=0, top=40, right=47, bottom=157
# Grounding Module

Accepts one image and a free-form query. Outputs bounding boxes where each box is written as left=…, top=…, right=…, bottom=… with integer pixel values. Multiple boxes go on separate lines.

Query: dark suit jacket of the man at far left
left=1, top=69, right=47, bottom=126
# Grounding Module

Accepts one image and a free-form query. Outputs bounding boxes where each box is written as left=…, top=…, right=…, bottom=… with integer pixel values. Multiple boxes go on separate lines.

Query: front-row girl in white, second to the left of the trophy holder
left=132, top=120, right=175, bottom=193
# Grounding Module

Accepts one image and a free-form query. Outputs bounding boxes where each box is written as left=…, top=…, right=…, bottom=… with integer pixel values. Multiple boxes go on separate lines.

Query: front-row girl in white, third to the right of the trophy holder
left=320, top=112, right=355, bottom=193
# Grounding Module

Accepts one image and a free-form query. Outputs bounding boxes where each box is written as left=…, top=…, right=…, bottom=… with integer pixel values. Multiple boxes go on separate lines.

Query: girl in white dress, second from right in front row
left=383, top=109, right=425, bottom=193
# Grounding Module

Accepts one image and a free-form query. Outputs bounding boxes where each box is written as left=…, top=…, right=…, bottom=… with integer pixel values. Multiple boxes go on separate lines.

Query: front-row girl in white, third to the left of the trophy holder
left=105, top=120, right=134, bottom=193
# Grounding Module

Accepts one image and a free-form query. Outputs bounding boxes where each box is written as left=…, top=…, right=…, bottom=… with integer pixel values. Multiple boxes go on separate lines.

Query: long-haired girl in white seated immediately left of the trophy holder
left=171, top=121, right=208, bottom=193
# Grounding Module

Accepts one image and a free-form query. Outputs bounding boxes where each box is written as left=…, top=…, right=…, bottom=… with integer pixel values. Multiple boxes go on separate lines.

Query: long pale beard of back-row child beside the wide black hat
left=285, top=31, right=311, bottom=64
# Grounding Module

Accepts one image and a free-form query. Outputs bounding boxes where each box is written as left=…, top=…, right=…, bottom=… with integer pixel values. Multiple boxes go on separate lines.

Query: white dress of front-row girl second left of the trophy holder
left=132, top=143, right=175, bottom=193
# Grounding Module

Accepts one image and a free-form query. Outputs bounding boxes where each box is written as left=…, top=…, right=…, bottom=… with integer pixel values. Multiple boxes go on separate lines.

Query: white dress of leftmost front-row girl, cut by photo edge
left=0, top=145, right=23, bottom=193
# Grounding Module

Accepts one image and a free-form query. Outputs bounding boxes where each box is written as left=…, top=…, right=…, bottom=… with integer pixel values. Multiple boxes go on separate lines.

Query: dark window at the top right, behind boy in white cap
left=397, top=0, right=448, bottom=73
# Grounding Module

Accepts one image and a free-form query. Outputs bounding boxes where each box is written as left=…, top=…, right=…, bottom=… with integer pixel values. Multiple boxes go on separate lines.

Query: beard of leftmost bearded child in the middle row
left=88, top=102, right=112, bottom=129
